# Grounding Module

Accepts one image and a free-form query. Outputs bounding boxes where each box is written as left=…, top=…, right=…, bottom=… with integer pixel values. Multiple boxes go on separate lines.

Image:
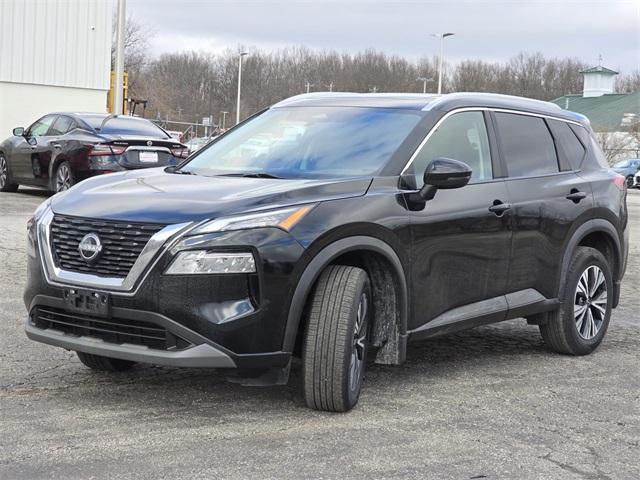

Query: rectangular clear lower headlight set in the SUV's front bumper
left=165, top=250, right=256, bottom=275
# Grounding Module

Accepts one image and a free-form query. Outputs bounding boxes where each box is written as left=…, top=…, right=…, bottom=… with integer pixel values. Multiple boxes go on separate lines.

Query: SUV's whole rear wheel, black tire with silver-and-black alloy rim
left=540, top=247, right=613, bottom=355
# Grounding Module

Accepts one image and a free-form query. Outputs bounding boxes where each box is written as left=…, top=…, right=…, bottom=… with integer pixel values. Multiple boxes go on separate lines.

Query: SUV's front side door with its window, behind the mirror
left=403, top=110, right=511, bottom=330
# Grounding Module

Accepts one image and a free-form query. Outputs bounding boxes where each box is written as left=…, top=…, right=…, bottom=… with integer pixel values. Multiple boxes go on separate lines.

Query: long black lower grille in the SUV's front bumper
left=31, top=306, right=189, bottom=350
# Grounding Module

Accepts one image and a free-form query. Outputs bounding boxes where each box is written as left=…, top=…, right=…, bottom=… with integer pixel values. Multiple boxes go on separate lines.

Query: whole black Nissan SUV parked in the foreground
left=24, top=93, right=628, bottom=411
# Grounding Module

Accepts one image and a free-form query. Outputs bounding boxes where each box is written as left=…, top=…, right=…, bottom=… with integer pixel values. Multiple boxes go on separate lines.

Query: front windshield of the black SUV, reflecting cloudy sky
left=182, top=107, right=422, bottom=178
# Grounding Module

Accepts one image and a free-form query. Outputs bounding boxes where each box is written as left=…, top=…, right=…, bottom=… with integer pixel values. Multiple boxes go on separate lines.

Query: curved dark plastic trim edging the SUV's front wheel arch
left=282, top=236, right=408, bottom=364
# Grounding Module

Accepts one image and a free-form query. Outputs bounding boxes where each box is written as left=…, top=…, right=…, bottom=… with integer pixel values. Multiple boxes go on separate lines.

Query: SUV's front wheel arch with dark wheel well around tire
left=283, top=236, right=408, bottom=364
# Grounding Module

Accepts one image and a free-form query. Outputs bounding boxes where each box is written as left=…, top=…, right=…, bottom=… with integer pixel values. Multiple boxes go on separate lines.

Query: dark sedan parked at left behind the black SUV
left=0, top=113, right=189, bottom=192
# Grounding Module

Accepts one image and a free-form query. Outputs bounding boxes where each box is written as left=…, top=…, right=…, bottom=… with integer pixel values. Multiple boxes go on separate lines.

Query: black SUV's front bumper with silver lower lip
left=24, top=211, right=304, bottom=369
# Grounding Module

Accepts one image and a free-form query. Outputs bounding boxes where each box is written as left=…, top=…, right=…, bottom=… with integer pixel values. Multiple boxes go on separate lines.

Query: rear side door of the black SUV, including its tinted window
left=492, top=112, right=593, bottom=298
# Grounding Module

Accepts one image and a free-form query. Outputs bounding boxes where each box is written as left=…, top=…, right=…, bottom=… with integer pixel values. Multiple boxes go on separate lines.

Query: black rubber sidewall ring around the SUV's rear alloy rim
left=562, top=248, right=613, bottom=354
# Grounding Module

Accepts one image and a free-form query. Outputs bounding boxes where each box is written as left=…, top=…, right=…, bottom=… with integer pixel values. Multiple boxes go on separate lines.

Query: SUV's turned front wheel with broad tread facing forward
left=302, top=265, right=373, bottom=412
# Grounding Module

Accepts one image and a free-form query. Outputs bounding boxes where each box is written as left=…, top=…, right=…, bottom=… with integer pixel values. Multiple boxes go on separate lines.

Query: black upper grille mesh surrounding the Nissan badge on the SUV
left=51, top=215, right=164, bottom=277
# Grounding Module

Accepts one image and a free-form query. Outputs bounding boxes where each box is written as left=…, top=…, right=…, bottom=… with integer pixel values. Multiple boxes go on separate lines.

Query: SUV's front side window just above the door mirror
left=409, top=112, right=493, bottom=186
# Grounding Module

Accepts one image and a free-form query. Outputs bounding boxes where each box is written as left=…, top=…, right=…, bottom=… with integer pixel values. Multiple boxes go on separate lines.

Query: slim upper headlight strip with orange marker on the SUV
left=191, top=205, right=315, bottom=234
